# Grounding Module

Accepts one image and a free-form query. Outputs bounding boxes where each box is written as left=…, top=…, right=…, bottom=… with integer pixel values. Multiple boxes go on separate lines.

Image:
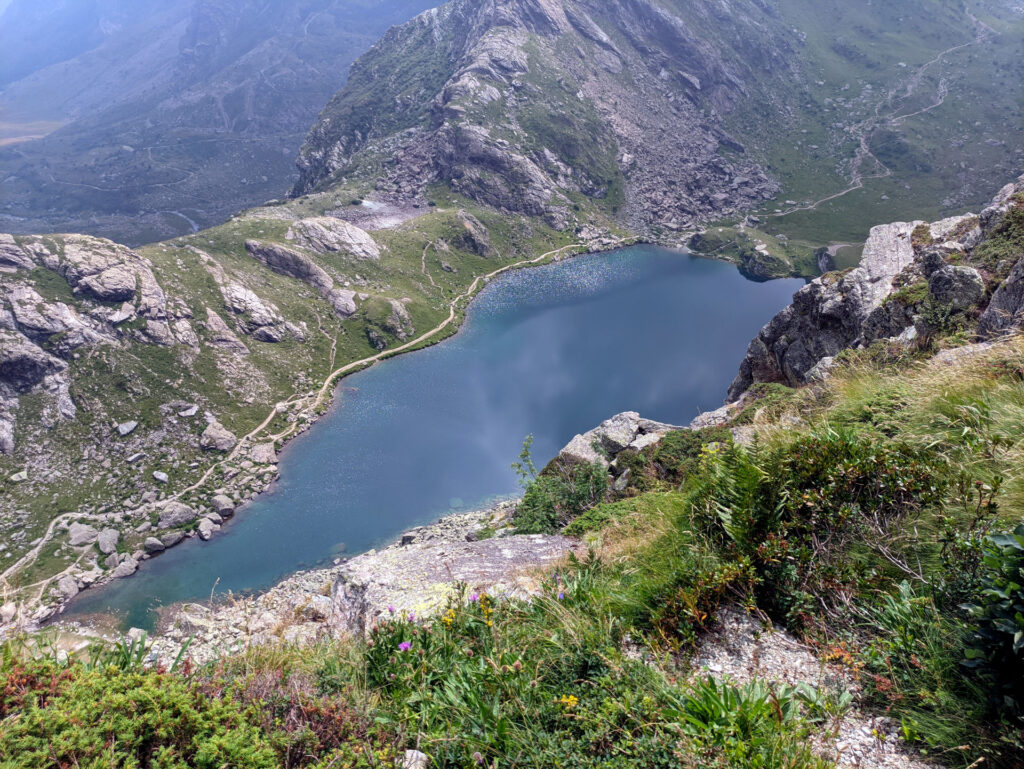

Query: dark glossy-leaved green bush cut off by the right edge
left=965, top=523, right=1024, bottom=718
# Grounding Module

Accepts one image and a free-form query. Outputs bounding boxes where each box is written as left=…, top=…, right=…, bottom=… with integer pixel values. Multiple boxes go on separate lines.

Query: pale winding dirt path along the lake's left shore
left=0, top=239, right=598, bottom=611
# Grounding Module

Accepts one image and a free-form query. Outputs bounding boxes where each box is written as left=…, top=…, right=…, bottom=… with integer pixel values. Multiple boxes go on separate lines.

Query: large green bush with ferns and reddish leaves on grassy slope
left=693, top=429, right=946, bottom=626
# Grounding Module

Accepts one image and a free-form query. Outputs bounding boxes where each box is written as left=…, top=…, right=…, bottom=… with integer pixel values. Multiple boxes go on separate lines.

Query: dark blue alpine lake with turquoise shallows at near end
left=71, top=247, right=801, bottom=627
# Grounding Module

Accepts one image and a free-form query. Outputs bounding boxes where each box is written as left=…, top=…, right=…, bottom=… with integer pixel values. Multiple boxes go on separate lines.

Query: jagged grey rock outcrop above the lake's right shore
left=729, top=177, right=1024, bottom=399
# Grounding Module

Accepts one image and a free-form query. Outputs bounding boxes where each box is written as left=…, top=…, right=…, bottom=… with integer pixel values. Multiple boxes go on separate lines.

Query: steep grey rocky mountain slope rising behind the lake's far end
left=296, top=0, right=794, bottom=231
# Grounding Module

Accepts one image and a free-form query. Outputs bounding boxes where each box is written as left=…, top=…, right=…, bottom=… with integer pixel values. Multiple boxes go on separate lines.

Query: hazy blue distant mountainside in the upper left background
left=0, top=0, right=431, bottom=243
